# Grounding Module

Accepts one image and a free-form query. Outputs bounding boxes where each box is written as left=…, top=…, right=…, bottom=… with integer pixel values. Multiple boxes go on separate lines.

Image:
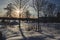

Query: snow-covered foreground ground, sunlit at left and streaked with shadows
left=0, top=23, right=60, bottom=40
